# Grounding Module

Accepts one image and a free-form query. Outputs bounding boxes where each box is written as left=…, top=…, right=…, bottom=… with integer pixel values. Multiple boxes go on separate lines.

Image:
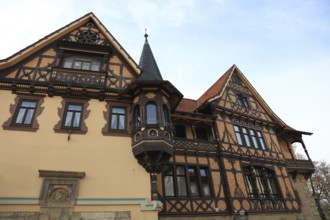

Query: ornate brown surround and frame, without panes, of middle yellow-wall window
left=54, top=98, right=90, bottom=134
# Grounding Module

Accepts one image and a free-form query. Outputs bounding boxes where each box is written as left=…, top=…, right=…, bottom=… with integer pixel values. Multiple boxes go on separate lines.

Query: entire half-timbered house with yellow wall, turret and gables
left=0, top=13, right=320, bottom=220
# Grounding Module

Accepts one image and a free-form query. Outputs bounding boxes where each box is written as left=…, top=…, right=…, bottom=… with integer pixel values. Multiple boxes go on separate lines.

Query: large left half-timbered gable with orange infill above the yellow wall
left=0, top=13, right=140, bottom=90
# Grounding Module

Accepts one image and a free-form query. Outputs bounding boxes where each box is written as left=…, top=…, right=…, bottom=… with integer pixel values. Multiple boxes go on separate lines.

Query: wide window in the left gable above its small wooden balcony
left=63, top=56, right=101, bottom=71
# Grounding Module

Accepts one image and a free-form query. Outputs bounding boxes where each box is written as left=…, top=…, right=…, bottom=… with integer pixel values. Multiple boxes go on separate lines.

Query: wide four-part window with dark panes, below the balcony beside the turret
left=163, top=165, right=213, bottom=198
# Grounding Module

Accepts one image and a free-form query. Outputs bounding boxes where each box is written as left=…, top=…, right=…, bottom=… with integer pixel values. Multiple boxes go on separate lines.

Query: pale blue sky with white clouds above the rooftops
left=0, top=0, right=330, bottom=163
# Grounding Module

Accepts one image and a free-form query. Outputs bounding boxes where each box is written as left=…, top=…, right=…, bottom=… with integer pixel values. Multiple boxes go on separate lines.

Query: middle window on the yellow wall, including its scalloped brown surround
left=54, top=99, right=90, bottom=134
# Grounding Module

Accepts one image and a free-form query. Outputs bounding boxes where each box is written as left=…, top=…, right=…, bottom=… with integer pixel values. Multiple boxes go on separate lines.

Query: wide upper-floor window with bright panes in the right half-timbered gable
left=234, top=125, right=267, bottom=150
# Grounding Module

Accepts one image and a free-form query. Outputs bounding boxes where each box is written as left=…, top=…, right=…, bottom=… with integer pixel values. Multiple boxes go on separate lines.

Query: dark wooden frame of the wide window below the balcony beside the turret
left=162, top=164, right=214, bottom=198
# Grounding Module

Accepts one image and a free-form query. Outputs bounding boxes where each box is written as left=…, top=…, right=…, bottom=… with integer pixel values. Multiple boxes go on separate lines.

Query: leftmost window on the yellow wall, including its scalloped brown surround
left=3, top=95, right=43, bottom=131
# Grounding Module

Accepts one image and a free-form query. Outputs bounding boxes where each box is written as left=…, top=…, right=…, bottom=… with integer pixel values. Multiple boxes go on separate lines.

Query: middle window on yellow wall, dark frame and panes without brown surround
left=63, top=103, right=83, bottom=129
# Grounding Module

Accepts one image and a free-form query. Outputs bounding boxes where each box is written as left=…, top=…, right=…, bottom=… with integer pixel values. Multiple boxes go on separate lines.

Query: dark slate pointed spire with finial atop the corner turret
left=137, top=30, right=163, bottom=81
